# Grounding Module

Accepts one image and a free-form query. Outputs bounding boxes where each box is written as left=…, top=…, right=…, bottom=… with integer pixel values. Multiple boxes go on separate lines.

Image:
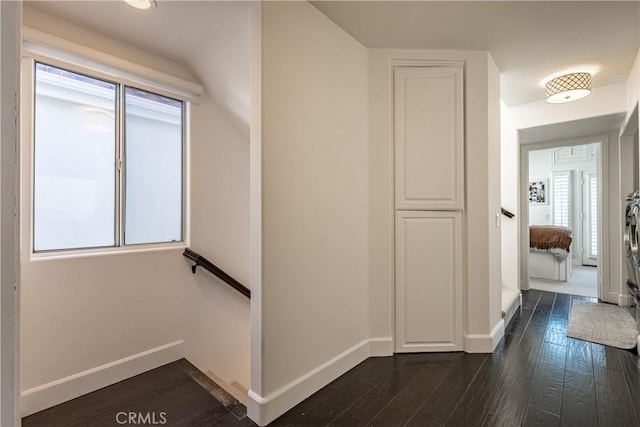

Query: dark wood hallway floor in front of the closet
left=272, top=290, right=640, bottom=427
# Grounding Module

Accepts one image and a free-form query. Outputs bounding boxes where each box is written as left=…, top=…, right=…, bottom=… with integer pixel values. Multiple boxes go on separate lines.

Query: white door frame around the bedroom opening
left=519, top=135, right=618, bottom=304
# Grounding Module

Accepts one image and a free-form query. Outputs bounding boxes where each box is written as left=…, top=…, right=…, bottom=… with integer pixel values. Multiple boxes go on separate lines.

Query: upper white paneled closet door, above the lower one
left=394, top=67, right=464, bottom=210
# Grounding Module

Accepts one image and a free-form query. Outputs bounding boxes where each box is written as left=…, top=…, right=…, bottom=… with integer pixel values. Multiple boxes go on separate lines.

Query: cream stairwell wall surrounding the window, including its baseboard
left=21, top=8, right=250, bottom=414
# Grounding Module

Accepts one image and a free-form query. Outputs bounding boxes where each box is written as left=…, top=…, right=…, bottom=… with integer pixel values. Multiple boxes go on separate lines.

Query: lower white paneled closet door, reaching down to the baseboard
left=396, top=211, right=463, bottom=352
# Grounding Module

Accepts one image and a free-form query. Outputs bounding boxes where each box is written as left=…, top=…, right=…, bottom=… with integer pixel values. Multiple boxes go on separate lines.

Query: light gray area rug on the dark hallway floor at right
left=567, top=301, right=638, bottom=349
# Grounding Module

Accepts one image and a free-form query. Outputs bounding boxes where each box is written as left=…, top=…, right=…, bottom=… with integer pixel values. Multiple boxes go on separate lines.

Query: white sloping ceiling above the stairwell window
left=25, top=0, right=255, bottom=138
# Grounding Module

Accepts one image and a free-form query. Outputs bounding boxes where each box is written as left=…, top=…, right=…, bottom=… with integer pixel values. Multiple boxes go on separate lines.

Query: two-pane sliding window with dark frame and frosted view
left=33, top=62, right=185, bottom=252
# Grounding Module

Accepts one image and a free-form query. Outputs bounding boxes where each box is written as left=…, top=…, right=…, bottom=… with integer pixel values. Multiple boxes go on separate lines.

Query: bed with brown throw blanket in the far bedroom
left=529, top=225, right=573, bottom=282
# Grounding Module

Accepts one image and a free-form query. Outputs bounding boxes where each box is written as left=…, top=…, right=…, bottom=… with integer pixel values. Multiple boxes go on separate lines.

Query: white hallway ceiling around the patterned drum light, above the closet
left=312, top=1, right=640, bottom=106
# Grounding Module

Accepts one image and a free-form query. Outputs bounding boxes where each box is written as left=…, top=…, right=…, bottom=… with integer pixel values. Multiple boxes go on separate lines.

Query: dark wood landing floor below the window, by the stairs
left=22, top=359, right=256, bottom=427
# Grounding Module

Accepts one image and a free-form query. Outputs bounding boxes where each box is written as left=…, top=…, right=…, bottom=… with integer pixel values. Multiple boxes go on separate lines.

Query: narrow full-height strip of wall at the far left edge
left=0, top=2, right=22, bottom=426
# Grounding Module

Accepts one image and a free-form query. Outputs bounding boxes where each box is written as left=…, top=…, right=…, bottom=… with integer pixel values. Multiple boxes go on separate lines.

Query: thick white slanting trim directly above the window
left=22, top=27, right=204, bottom=102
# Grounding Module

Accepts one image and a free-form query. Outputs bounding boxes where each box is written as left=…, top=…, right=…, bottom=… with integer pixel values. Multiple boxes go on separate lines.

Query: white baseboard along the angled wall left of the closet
left=247, top=337, right=393, bottom=426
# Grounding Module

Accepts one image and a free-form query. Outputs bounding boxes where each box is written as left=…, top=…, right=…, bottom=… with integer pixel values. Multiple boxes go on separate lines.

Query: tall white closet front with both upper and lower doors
left=393, top=63, right=464, bottom=352
